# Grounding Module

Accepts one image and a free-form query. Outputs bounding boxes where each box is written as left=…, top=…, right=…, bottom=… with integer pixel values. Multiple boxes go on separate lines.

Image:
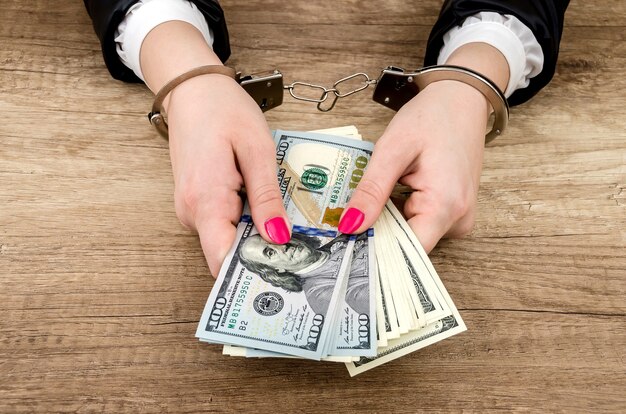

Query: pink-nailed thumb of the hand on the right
left=338, top=142, right=406, bottom=234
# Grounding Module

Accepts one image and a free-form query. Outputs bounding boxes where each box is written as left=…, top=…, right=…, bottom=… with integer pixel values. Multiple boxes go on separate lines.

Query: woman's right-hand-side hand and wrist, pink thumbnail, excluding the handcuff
left=339, top=43, right=509, bottom=251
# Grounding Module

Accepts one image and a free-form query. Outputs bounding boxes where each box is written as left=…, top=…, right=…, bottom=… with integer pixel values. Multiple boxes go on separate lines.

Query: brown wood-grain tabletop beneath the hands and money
left=0, top=0, right=626, bottom=413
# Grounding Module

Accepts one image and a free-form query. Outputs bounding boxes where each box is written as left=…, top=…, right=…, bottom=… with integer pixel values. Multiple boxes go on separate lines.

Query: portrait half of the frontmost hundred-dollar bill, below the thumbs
left=196, top=216, right=354, bottom=360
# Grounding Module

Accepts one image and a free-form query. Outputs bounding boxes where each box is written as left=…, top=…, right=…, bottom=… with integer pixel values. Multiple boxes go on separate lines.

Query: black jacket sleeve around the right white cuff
left=424, top=0, right=569, bottom=105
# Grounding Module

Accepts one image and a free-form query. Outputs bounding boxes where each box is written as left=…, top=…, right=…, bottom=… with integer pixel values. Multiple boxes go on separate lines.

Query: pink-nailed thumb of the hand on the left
left=235, top=136, right=291, bottom=244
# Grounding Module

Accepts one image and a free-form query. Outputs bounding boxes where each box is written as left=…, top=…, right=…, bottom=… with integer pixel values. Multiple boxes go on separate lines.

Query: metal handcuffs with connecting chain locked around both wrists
left=148, top=65, right=509, bottom=144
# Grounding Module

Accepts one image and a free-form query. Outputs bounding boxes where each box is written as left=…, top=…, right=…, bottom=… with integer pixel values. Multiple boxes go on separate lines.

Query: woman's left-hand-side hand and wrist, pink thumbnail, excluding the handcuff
left=141, top=21, right=291, bottom=277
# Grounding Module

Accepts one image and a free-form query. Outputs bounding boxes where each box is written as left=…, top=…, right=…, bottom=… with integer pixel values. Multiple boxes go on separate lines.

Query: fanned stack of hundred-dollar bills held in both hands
left=196, top=127, right=466, bottom=376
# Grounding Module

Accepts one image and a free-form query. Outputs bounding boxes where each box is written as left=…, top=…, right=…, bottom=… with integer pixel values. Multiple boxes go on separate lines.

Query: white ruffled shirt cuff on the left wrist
left=115, top=0, right=213, bottom=82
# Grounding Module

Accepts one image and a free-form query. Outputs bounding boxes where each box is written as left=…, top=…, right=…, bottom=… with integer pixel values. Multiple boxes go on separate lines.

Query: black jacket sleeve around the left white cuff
left=84, top=0, right=230, bottom=82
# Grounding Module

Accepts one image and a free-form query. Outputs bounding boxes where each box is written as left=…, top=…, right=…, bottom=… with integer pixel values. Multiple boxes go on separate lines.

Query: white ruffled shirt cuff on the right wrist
left=437, top=12, right=543, bottom=98
